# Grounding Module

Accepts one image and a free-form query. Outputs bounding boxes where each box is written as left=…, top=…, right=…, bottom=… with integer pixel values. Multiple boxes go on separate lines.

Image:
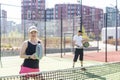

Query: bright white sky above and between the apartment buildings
left=0, top=0, right=120, bottom=22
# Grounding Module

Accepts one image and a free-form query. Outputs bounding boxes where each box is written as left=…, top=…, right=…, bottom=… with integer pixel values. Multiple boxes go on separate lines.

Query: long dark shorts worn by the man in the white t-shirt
left=73, top=48, right=83, bottom=62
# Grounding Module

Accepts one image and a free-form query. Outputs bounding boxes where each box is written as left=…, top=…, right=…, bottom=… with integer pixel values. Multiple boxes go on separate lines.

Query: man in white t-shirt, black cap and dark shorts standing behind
left=73, top=30, right=85, bottom=68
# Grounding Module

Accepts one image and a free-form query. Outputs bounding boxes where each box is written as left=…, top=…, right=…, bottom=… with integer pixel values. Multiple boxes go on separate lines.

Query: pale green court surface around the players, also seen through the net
left=0, top=56, right=120, bottom=80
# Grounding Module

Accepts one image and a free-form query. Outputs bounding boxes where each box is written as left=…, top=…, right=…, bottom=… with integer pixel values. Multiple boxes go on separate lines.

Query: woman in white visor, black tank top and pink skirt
left=20, top=26, right=42, bottom=80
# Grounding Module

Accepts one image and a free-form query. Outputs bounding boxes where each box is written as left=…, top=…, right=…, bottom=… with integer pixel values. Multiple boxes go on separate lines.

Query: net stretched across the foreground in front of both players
left=0, top=62, right=120, bottom=80
